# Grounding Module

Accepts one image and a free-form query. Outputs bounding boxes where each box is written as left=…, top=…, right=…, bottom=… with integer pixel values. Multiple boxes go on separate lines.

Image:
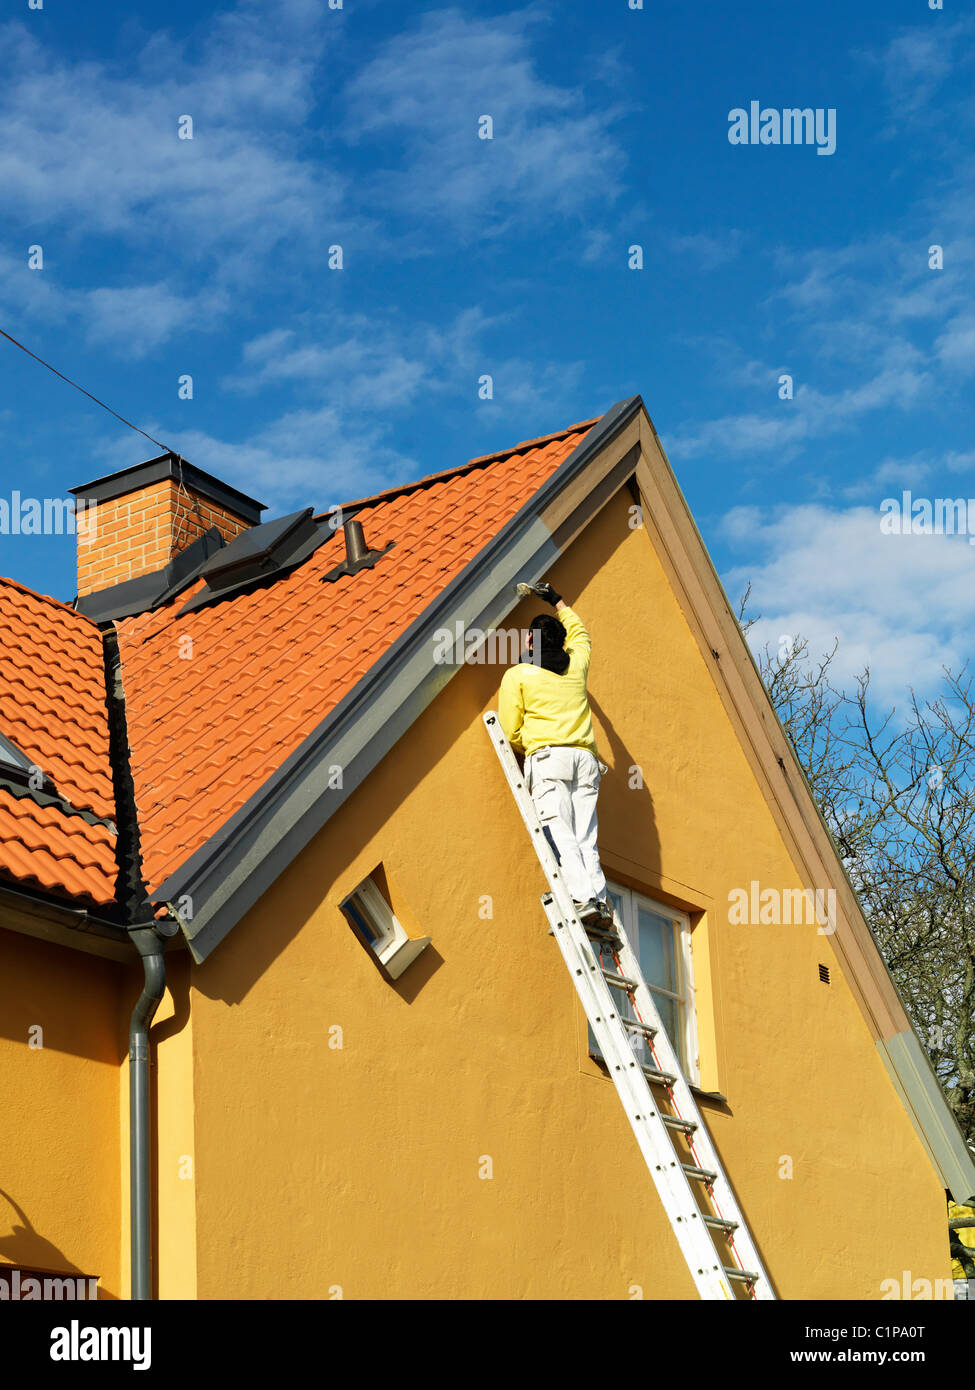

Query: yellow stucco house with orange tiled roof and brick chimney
left=0, top=398, right=975, bottom=1300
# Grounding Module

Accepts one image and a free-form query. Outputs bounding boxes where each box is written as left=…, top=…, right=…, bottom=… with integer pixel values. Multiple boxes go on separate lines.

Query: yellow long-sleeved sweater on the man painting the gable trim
left=498, top=606, right=599, bottom=758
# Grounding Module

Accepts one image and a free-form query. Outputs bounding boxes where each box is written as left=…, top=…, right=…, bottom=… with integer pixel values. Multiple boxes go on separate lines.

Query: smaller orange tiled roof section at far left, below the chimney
left=0, top=580, right=117, bottom=905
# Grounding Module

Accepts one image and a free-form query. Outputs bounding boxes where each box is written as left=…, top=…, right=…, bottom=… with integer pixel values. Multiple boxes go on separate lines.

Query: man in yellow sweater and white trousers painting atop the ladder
left=498, top=584, right=612, bottom=922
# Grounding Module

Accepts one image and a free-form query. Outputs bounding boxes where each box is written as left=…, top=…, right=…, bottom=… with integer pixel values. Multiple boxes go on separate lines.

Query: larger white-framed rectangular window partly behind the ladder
left=590, top=883, right=701, bottom=1086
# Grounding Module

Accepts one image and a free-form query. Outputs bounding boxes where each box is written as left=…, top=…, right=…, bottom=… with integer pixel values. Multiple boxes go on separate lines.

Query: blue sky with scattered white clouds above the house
left=0, top=0, right=975, bottom=701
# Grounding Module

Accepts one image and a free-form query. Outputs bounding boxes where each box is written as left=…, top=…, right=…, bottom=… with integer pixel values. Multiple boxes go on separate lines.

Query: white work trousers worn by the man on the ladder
left=524, top=748, right=606, bottom=902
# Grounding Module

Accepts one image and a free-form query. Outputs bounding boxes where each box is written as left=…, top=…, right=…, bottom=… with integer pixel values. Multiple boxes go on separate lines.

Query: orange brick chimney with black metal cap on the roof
left=71, top=453, right=266, bottom=598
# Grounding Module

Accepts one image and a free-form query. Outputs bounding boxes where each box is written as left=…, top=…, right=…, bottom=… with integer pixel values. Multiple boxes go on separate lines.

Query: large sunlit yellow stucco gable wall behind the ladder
left=182, top=492, right=950, bottom=1298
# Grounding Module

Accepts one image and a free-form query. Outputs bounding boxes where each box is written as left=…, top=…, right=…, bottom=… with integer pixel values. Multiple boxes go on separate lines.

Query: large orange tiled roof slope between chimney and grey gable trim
left=118, top=421, right=595, bottom=894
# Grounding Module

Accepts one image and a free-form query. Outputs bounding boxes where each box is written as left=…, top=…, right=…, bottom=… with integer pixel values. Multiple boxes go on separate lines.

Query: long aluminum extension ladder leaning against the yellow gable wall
left=483, top=710, right=776, bottom=1300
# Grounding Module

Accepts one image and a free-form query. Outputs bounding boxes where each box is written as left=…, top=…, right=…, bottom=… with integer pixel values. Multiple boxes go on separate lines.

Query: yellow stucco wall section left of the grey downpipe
left=0, top=930, right=124, bottom=1298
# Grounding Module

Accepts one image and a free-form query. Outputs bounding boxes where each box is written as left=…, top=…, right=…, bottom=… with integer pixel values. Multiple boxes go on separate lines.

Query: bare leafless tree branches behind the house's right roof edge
left=739, top=594, right=975, bottom=1145
